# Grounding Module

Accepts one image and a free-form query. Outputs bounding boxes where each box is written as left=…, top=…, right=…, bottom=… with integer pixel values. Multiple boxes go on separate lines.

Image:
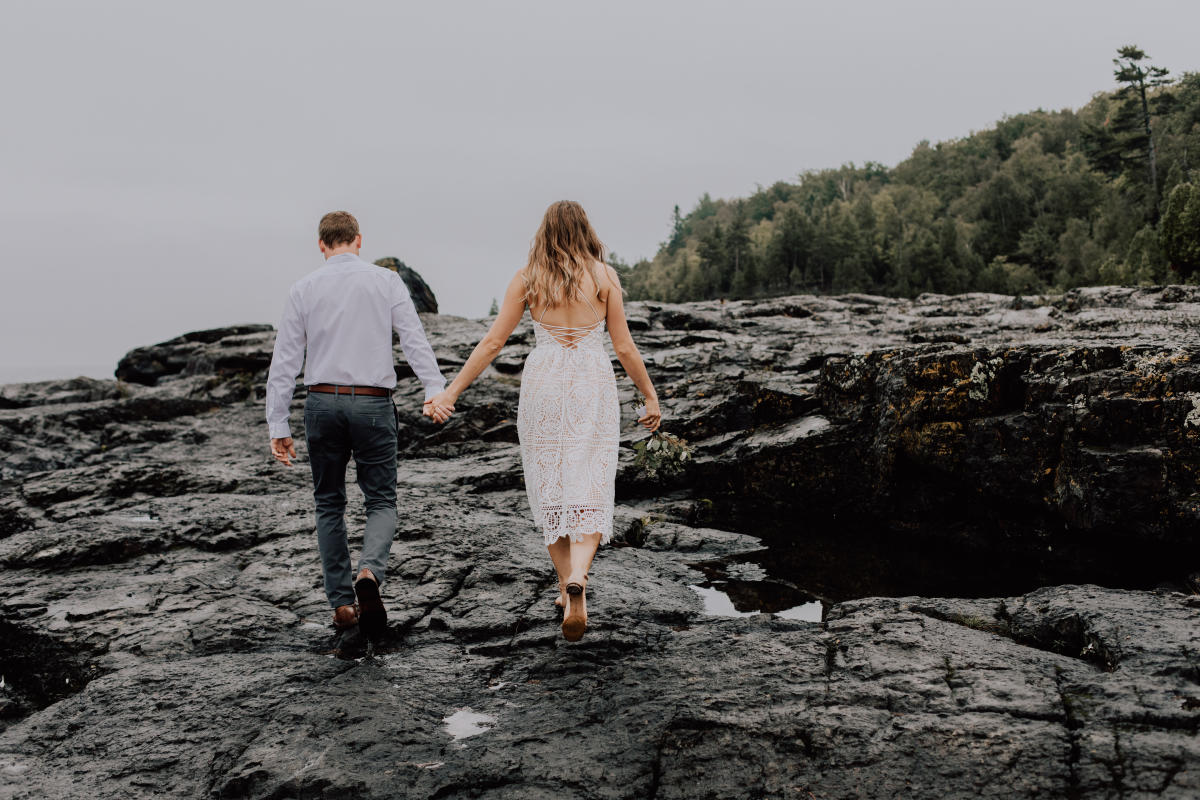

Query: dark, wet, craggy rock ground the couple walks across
left=0, top=287, right=1200, bottom=799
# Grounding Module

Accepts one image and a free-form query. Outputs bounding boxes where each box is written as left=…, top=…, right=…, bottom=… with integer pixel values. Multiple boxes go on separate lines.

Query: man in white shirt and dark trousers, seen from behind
left=266, top=211, right=449, bottom=639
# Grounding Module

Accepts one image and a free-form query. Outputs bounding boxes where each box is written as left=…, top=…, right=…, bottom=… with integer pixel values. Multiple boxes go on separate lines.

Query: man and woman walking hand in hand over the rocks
left=266, top=200, right=661, bottom=642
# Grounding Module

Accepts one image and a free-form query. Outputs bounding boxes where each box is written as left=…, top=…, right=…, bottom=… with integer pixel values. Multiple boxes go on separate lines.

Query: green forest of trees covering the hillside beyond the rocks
left=612, top=46, right=1200, bottom=301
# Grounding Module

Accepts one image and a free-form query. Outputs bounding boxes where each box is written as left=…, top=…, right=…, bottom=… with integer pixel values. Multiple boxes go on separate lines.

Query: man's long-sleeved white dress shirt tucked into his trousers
left=266, top=253, right=445, bottom=439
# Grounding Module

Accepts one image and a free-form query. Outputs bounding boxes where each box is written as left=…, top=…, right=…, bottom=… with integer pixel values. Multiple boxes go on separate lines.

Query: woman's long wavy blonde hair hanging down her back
left=523, top=200, right=604, bottom=308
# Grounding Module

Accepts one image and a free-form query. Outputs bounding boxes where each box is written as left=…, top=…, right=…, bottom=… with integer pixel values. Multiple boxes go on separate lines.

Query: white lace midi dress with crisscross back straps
left=517, top=303, right=620, bottom=545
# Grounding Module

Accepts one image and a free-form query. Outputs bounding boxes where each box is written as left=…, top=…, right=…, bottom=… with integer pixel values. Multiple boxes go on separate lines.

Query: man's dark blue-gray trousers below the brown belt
left=304, top=392, right=396, bottom=608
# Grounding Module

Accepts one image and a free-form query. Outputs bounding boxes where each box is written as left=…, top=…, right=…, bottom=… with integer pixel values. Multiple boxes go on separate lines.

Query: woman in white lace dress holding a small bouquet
left=425, top=200, right=661, bottom=642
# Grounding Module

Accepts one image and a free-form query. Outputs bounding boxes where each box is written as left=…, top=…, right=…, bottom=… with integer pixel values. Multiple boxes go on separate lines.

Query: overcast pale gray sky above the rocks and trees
left=0, top=0, right=1200, bottom=380
